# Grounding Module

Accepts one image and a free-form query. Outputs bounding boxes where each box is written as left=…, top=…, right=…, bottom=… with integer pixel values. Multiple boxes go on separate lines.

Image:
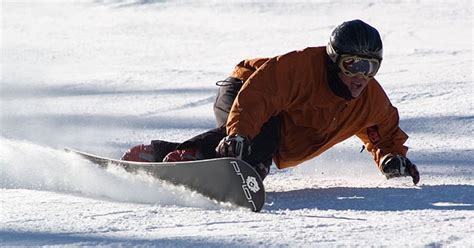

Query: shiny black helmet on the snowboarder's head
left=326, top=20, right=383, bottom=63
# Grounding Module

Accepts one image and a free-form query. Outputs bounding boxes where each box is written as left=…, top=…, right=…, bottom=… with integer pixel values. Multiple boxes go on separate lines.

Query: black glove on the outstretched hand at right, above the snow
left=382, top=154, right=420, bottom=185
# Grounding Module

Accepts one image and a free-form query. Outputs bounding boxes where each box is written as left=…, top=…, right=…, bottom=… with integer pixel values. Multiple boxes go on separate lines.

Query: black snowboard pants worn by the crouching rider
left=152, top=78, right=281, bottom=178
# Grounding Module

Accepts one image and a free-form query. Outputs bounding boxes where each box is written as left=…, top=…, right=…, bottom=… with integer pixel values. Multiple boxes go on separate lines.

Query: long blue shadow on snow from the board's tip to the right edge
left=265, top=185, right=474, bottom=211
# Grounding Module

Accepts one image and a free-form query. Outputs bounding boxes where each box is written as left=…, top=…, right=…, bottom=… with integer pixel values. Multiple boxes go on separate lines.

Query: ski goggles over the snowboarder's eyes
left=339, top=55, right=380, bottom=79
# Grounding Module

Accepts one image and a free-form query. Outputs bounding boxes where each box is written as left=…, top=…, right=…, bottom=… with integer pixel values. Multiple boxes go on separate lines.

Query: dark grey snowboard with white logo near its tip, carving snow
left=64, top=148, right=265, bottom=212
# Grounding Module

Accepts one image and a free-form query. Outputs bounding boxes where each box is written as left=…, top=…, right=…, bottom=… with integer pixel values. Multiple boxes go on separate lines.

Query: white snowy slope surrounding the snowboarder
left=0, top=0, right=474, bottom=247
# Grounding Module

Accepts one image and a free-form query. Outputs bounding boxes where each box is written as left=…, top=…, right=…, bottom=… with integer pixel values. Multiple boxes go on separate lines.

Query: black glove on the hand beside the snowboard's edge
left=216, top=134, right=250, bottom=160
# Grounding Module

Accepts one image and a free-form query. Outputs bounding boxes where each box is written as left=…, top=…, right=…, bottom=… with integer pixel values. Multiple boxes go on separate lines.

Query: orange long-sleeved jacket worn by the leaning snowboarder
left=227, top=47, right=408, bottom=168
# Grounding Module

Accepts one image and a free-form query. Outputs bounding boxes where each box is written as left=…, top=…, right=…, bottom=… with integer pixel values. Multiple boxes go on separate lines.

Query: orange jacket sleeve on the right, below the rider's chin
left=357, top=84, right=408, bottom=169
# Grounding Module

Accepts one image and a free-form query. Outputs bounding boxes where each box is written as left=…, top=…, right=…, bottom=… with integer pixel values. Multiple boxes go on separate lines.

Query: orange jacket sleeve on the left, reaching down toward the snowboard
left=227, top=56, right=297, bottom=139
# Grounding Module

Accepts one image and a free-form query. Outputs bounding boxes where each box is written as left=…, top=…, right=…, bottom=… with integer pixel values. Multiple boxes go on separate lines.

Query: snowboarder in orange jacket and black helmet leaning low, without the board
left=122, top=20, right=420, bottom=184
